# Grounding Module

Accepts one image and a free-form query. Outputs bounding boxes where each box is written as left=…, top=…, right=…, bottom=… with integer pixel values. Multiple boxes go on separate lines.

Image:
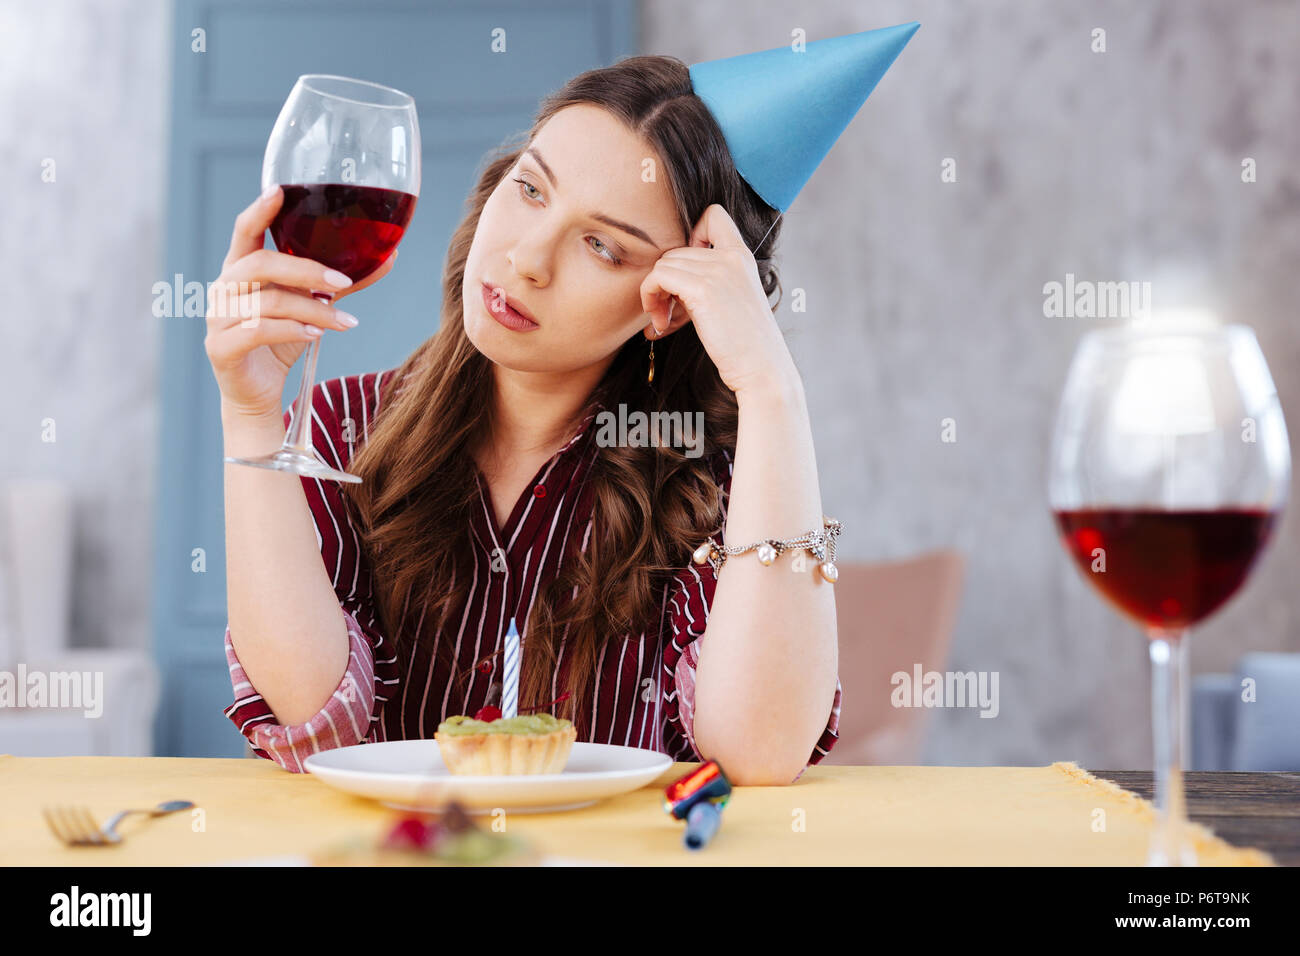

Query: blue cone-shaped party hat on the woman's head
left=690, top=21, right=920, bottom=214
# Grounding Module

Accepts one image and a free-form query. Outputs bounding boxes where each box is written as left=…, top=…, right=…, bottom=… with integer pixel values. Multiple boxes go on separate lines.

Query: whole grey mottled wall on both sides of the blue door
left=0, top=0, right=1300, bottom=767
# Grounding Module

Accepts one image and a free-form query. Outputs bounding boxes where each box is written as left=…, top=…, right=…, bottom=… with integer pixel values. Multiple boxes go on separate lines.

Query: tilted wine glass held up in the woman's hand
left=225, top=74, right=420, bottom=483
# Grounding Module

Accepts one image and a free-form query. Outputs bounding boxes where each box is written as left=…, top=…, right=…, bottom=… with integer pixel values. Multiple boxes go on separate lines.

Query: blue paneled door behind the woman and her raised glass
left=153, top=0, right=636, bottom=757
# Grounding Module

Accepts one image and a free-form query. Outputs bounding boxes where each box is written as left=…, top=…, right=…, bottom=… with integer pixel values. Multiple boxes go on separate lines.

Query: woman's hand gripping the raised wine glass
left=203, top=186, right=398, bottom=418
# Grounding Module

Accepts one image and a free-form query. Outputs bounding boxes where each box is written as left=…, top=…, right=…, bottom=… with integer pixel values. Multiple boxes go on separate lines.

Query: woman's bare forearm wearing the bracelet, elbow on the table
left=694, top=363, right=839, bottom=784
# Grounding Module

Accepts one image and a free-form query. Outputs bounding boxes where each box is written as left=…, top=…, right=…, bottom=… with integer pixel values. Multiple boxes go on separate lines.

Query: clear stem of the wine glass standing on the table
left=1147, top=628, right=1196, bottom=866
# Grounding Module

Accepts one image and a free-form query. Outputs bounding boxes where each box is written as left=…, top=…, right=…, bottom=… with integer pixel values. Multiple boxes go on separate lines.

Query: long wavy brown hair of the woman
left=343, top=56, right=781, bottom=740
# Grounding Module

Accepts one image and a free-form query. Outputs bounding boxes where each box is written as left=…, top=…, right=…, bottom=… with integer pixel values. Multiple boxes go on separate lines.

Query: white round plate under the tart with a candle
left=303, top=740, right=672, bottom=813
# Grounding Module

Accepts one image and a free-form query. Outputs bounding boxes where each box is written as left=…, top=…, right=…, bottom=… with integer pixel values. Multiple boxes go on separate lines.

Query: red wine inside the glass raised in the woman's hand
left=270, top=182, right=416, bottom=282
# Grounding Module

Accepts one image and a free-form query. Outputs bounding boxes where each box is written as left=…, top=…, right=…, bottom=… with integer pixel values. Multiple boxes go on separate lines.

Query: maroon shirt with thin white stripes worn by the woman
left=224, top=369, right=841, bottom=780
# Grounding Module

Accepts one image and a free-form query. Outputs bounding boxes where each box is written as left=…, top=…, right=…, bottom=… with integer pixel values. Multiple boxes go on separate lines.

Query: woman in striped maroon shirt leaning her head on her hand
left=205, top=56, right=841, bottom=784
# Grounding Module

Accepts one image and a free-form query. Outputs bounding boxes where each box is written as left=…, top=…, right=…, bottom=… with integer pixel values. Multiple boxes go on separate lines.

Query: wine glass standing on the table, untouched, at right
left=1048, top=323, right=1291, bottom=866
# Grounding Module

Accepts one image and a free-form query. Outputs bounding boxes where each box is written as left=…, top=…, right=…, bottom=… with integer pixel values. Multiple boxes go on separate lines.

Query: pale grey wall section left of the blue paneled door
left=0, top=0, right=170, bottom=658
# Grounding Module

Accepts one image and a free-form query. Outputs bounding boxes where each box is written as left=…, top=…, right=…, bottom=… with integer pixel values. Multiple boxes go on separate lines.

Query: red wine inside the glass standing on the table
left=1054, top=507, right=1278, bottom=633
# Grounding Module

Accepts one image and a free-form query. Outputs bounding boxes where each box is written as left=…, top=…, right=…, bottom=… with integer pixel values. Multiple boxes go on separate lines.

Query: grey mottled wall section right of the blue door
left=644, top=0, right=1300, bottom=767
